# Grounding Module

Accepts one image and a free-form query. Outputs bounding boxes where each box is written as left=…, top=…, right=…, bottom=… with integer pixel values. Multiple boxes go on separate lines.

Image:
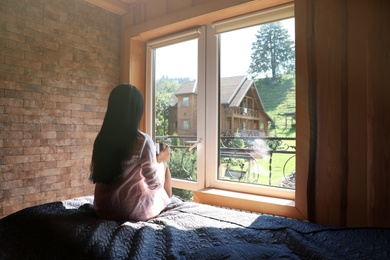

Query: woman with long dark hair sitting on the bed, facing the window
left=90, top=84, right=172, bottom=221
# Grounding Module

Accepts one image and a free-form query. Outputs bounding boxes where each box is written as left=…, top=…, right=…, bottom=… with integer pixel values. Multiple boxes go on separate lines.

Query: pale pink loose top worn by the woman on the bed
left=94, top=132, right=170, bottom=221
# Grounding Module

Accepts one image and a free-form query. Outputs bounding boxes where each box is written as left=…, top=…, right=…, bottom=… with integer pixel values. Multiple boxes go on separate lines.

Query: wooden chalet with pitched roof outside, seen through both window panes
left=168, top=75, right=272, bottom=136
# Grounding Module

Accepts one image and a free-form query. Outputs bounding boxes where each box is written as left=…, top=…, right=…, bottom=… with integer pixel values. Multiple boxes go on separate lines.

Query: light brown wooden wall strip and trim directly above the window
left=122, top=0, right=293, bottom=41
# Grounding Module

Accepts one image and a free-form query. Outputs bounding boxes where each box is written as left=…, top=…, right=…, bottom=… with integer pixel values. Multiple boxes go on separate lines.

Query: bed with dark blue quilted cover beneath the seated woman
left=0, top=196, right=390, bottom=259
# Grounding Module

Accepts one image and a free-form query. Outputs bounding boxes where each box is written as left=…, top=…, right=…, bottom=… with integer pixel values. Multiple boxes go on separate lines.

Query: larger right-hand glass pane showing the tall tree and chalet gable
left=218, top=18, right=295, bottom=189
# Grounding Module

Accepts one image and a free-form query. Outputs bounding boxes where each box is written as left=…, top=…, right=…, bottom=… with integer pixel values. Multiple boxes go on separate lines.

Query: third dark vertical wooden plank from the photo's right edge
left=314, top=0, right=347, bottom=228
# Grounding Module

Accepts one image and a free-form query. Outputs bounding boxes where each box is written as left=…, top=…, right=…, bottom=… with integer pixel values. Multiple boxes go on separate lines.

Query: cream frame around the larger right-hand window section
left=201, top=4, right=296, bottom=200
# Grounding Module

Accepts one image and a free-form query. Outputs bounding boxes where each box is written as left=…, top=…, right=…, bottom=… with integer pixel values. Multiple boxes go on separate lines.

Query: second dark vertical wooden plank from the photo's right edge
left=347, top=0, right=370, bottom=226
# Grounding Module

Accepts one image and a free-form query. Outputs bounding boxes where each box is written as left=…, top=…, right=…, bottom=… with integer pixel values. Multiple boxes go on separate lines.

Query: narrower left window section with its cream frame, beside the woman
left=145, top=28, right=205, bottom=193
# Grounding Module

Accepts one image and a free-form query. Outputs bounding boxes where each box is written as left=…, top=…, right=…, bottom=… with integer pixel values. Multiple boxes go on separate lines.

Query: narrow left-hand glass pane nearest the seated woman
left=153, top=39, right=198, bottom=181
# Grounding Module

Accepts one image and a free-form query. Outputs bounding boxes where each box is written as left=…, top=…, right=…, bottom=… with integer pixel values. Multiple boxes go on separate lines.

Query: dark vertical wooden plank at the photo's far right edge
left=366, top=0, right=390, bottom=227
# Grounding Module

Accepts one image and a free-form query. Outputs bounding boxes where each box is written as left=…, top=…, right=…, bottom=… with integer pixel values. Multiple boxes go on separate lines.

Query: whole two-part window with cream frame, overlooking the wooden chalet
left=147, top=5, right=295, bottom=199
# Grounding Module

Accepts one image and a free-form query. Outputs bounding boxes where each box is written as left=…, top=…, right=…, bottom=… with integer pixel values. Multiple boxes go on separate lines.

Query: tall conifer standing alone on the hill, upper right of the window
left=248, top=21, right=295, bottom=79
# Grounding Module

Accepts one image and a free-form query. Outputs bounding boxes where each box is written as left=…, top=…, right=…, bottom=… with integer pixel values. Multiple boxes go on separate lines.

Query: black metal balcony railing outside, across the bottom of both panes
left=157, top=136, right=296, bottom=189
